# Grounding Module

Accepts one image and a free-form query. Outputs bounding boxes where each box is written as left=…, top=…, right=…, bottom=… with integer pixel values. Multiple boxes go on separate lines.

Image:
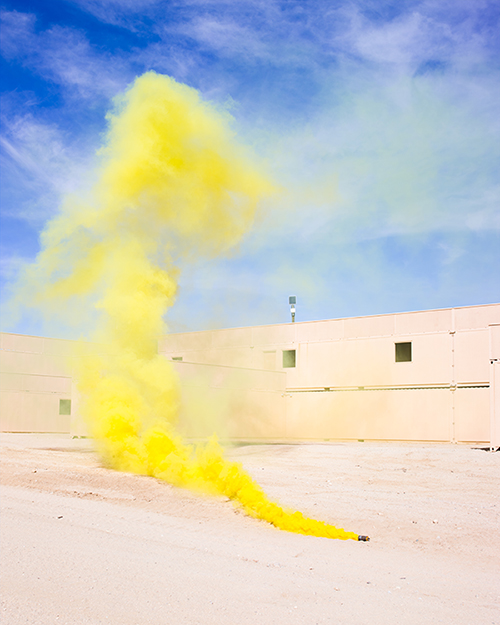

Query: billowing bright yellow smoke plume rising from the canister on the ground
left=21, top=72, right=358, bottom=540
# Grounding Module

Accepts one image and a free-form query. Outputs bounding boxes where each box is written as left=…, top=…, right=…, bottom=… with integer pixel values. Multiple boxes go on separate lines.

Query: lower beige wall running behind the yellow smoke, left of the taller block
left=0, top=333, right=286, bottom=439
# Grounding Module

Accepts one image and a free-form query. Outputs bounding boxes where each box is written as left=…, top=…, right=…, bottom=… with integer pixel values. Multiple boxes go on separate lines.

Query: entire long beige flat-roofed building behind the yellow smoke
left=1, top=304, right=500, bottom=447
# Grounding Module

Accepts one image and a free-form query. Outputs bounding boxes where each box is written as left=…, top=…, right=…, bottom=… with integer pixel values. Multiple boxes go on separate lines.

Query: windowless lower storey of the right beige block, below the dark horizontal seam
left=286, top=388, right=489, bottom=442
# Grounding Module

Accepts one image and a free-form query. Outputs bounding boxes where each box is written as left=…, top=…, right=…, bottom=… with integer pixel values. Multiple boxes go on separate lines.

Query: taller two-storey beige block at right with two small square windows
left=159, top=304, right=500, bottom=445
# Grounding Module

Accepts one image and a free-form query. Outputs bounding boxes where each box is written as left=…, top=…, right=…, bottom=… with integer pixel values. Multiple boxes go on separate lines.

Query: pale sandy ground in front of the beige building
left=0, top=434, right=500, bottom=625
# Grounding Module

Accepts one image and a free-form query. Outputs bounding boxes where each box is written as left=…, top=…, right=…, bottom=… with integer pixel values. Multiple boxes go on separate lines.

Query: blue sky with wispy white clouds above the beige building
left=0, top=0, right=500, bottom=334
